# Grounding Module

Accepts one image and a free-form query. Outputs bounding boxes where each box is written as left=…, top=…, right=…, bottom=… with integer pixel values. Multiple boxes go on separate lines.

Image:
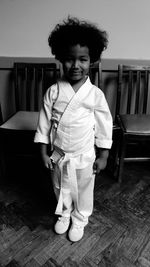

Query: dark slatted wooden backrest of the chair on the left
left=14, top=62, right=60, bottom=111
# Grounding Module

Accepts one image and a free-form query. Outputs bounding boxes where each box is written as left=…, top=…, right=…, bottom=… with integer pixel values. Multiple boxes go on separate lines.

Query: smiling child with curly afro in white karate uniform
left=34, top=18, right=112, bottom=242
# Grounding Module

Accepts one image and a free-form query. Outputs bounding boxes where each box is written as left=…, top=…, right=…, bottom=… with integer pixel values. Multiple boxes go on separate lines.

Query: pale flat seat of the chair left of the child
left=0, top=111, right=39, bottom=131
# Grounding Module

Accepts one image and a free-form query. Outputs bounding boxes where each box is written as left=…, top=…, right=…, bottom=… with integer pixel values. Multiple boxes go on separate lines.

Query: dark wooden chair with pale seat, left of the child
left=0, top=63, right=60, bottom=179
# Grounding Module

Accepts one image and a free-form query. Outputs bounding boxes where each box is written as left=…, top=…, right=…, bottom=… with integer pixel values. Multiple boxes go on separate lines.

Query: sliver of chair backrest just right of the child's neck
left=89, top=61, right=103, bottom=90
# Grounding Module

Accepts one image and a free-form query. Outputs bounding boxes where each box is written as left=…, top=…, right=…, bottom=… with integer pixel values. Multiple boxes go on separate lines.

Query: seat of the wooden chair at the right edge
left=119, top=114, right=150, bottom=134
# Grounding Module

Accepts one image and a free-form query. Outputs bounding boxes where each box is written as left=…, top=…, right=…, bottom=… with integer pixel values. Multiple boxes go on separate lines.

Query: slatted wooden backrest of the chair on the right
left=116, top=64, right=150, bottom=118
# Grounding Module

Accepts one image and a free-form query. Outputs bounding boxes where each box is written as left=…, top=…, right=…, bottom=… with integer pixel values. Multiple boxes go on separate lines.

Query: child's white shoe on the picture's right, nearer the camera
left=68, top=223, right=84, bottom=242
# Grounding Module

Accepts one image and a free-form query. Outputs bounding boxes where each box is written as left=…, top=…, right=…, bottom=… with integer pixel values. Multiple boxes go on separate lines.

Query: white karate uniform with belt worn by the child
left=34, top=77, right=112, bottom=224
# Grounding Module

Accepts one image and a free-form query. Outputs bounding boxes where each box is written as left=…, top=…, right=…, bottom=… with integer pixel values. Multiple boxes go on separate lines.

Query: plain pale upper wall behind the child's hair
left=0, top=0, right=150, bottom=59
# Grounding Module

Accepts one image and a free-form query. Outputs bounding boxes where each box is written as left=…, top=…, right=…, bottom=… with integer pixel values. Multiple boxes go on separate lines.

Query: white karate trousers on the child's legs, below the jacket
left=53, top=153, right=95, bottom=225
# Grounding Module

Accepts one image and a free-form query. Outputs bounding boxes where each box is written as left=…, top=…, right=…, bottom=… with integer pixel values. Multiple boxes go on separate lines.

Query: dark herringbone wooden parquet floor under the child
left=0, top=159, right=150, bottom=267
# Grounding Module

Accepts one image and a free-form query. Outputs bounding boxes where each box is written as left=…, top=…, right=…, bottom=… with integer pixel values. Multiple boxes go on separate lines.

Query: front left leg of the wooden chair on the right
left=118, top=133, right=126, bottom=184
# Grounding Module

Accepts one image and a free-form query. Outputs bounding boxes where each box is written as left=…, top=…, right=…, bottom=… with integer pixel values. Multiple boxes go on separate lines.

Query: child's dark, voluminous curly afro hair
left=48, top=17, right=108, bottom=63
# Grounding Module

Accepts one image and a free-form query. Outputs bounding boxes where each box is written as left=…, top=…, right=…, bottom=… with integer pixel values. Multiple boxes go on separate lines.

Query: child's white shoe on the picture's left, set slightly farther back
left=54, top=216, right=70, bottom=235
